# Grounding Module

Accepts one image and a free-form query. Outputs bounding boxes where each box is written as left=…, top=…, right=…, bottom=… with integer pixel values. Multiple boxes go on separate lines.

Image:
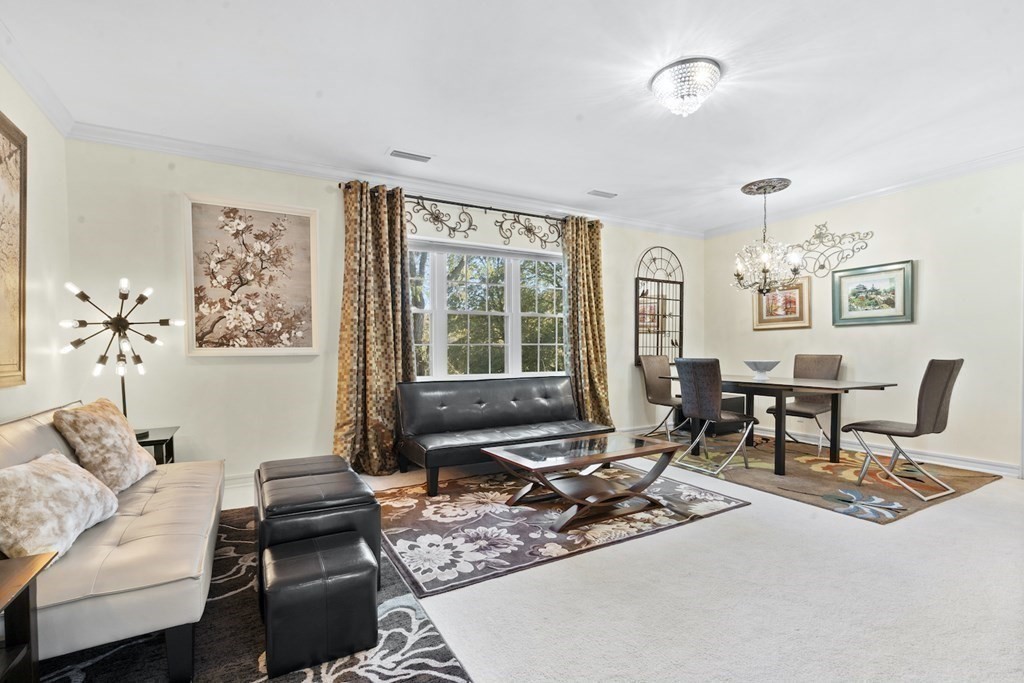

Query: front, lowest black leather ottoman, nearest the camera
left=262, top=531, right=378, bottom=678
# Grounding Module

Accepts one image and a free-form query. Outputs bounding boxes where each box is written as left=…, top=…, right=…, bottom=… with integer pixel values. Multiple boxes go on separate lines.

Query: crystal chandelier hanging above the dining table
left=732, top=178, right=803, bottom=295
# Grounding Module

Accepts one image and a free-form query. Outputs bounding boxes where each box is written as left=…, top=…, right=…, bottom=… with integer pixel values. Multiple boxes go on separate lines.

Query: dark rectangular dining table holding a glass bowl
left=662, top=375, right=896, bottom=475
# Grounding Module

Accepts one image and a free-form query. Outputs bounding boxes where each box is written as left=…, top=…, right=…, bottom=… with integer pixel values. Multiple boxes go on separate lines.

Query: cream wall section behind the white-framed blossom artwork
left=61, top=140, right=344, bottom=482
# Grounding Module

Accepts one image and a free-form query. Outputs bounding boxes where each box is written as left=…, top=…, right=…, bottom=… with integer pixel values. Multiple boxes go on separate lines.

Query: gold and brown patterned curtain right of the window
left=562, top=216, right=613, bottom=426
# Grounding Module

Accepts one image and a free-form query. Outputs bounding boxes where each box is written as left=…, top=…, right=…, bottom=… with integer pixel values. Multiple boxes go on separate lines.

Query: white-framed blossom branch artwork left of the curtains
left=185, top=197, right=317, bottom=355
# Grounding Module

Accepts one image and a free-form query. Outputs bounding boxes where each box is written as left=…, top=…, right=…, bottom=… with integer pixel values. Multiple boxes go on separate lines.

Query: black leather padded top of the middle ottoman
left=262, top=471, right=375, bottom=518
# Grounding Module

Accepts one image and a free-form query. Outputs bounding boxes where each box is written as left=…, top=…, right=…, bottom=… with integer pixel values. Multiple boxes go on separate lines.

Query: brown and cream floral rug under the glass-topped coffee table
left=377, top=464, right=750, bottom=597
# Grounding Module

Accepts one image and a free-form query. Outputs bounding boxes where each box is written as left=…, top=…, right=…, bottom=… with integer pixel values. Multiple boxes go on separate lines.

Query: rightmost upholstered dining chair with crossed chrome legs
left=843, top=358, right=964, bottom=501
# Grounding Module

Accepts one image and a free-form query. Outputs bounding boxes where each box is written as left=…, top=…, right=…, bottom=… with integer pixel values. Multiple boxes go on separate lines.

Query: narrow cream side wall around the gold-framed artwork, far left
left=0, top=62, right=68, bottom=421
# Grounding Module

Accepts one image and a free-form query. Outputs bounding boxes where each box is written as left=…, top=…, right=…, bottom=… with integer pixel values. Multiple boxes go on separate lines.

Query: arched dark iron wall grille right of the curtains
left=634, top=247, right=683, bottom=366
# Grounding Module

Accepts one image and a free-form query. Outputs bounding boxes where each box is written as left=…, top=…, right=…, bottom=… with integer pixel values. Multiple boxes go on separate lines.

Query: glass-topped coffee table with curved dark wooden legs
left=483, top=432, right=679, bottom=531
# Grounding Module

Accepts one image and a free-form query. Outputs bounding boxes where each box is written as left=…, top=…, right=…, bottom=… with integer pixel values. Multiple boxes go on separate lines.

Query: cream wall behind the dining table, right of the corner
left=705, top=164, right=1024, bottom=471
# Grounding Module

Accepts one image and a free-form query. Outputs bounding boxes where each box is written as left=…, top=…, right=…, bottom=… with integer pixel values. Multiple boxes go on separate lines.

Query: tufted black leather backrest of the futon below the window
left=398, top=377, right=580, bottom=436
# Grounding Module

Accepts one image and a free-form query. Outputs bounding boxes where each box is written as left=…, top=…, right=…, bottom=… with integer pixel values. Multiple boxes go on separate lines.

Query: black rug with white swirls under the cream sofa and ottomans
left=40, top=508, right=470, bottom=683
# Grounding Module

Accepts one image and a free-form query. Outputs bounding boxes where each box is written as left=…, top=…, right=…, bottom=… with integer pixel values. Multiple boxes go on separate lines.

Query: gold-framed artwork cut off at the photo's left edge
left=0, top=114, right=29, bottom=387
